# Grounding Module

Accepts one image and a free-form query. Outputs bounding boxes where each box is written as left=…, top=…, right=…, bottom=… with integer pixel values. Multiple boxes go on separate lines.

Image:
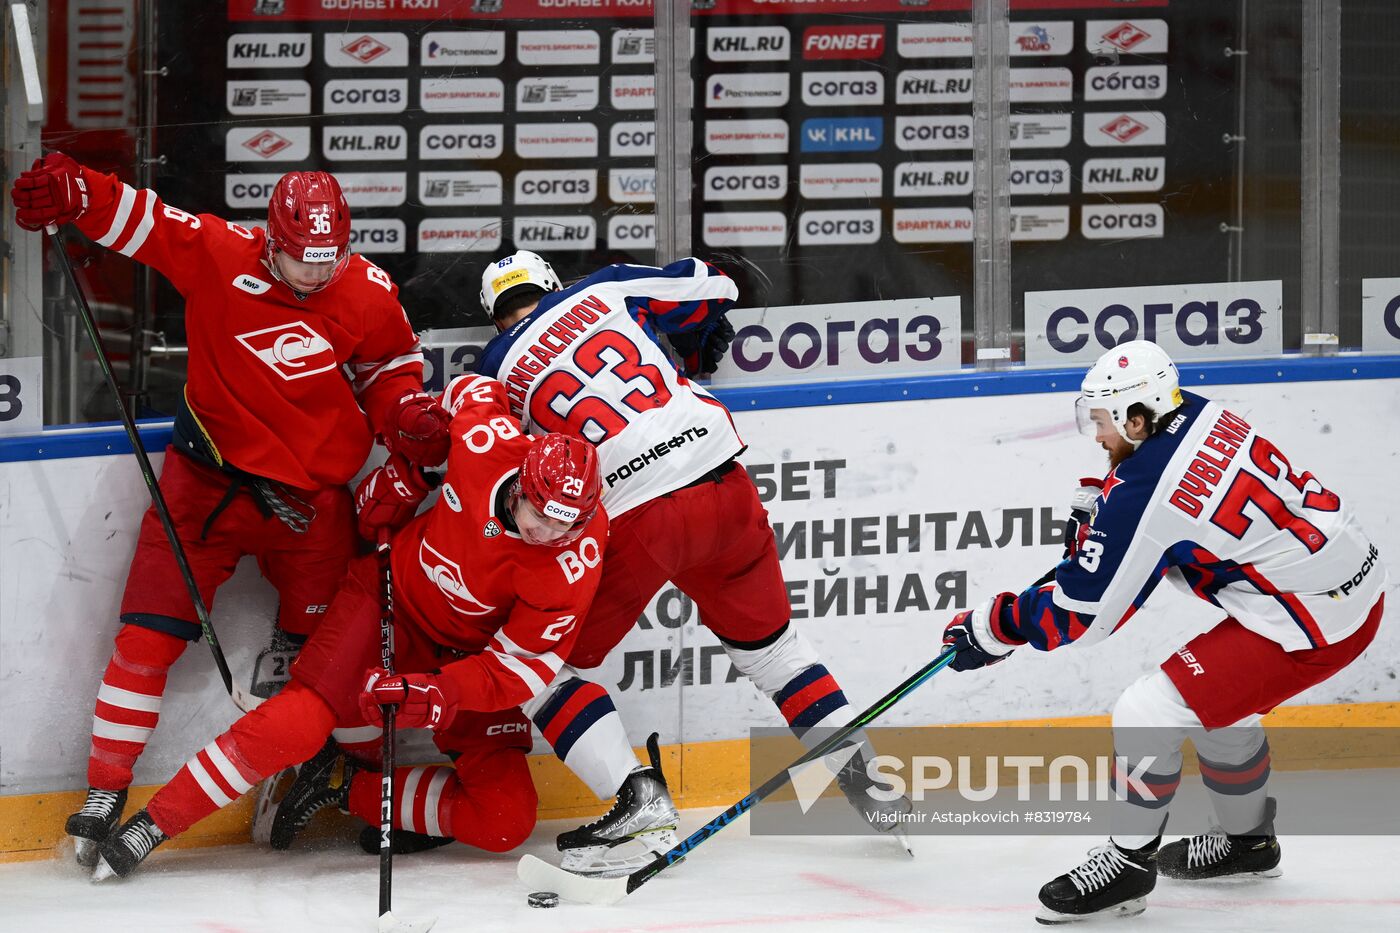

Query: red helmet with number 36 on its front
left=267, top=172, right=350, bottom=287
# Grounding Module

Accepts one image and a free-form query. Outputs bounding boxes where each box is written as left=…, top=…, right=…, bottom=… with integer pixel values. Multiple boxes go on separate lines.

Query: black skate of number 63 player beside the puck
left=557, top=733, right=680, bottom=878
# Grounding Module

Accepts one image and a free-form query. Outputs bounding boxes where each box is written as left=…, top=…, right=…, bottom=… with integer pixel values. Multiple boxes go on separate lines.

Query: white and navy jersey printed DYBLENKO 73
left=997, top=392, right=1386, bottom=651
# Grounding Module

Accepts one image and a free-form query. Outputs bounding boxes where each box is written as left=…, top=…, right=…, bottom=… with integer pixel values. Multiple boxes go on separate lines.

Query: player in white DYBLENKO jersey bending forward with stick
left=944, top=340, right=1386, bottom=923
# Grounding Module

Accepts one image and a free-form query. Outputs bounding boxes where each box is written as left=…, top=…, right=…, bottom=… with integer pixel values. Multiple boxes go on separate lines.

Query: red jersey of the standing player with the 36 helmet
left=77, top=168, right=423, bottom=489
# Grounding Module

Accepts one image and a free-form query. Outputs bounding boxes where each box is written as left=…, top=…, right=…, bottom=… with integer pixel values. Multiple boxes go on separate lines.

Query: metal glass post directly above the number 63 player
left=655, top=0, right=693, bottom=265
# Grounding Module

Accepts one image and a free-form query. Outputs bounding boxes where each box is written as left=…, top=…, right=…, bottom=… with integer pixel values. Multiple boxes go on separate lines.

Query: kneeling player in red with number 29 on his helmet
left=98, top=375, right=608, bottom=877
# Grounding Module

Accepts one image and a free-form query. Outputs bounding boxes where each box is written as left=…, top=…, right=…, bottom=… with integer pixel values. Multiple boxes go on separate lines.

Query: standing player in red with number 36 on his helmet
left=10, top=153, right=448, bottom=866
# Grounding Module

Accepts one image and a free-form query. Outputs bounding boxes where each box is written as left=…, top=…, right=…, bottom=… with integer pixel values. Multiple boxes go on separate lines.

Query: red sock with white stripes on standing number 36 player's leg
left=88, top=625, right=189, bottom=790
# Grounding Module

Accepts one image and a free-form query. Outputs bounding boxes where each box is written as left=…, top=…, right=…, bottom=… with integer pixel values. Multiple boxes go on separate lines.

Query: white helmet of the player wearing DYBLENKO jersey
left=1074, top=340, right=1182, bottom=448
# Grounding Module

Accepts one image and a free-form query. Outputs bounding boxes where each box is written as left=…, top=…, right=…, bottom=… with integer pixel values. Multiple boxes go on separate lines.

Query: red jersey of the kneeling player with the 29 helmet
left=392, top=375, right=608, bottom=710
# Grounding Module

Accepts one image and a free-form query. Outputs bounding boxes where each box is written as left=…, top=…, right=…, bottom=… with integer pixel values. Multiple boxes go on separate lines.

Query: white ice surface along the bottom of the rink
left=0, top=810, right=1400, bottom=933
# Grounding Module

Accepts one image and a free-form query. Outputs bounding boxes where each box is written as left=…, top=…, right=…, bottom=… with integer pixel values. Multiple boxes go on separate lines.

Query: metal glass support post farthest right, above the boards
left=1301, top=0, right=1341, bottom=354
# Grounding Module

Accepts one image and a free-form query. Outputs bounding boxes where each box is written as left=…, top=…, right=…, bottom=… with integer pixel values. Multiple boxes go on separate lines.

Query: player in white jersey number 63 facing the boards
left=480, top=249, right=910, bottom=876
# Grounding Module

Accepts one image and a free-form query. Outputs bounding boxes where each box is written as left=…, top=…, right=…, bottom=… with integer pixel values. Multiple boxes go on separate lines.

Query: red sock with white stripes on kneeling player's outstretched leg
left=146, top=681, right=336, bottom=836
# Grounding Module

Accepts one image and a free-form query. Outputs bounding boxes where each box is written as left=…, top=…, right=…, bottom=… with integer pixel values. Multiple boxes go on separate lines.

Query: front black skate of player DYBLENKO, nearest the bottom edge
left=1036, top=839, right=1156, bottom=923
